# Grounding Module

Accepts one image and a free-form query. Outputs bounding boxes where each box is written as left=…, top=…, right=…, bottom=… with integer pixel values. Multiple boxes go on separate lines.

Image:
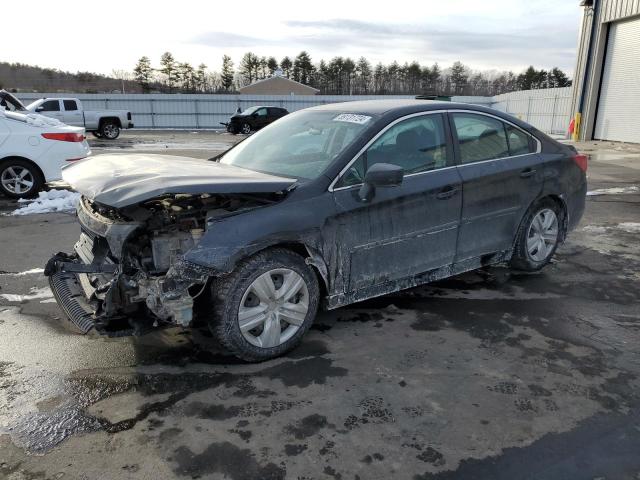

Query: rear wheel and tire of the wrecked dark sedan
left=510, top=198, right=564, bottom=272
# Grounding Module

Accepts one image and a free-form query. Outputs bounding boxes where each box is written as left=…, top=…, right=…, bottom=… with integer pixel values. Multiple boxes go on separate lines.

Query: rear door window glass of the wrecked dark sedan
left=452, top=113, right=510, bottom=163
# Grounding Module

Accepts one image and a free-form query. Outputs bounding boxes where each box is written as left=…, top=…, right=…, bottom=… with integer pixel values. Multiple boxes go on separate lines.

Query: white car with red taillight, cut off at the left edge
left=0, top=90, right=91, bottom=198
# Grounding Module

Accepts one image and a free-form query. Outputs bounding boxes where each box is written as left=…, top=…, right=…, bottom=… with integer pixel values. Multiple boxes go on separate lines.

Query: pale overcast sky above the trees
left=0, top=0, right=581, bottom=73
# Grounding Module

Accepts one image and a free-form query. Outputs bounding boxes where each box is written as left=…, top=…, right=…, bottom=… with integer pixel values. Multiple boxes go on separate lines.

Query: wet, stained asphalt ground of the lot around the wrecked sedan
left=0, top=132, right=640, bottom=480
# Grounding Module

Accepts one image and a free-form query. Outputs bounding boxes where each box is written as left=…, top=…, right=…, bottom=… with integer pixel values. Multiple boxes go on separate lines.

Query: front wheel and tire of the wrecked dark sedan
left=209, top=248, right=320, bottom=362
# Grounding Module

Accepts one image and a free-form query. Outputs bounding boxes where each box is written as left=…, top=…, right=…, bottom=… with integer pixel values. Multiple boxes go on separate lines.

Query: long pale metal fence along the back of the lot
left=18, top=88, right=571, bottom=133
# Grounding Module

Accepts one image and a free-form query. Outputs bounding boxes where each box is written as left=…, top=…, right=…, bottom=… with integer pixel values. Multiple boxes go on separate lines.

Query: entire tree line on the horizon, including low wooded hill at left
left=0, top=52, right=571, bottom=96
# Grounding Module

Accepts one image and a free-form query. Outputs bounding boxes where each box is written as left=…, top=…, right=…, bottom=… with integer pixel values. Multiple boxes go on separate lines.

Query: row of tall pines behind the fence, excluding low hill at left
left=133, top=51, right=571, bottom=96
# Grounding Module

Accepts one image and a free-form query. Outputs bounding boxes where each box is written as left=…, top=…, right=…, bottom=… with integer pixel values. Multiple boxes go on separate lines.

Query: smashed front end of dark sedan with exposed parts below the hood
left=45, top=194, right=272, bottom=335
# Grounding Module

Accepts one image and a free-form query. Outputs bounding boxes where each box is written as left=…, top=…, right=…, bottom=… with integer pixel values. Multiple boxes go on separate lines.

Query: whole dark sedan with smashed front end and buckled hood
left=45, top=100, right=587, bottom=361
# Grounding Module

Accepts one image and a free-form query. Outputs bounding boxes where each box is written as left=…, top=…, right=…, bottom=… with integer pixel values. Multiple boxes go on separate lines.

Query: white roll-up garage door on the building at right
left=593, top=18, right=640, bottom=143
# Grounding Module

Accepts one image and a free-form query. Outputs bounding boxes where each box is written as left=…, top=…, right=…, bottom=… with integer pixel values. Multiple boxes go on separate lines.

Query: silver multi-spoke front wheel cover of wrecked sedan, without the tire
left=238, top=268, right=309, bottom=348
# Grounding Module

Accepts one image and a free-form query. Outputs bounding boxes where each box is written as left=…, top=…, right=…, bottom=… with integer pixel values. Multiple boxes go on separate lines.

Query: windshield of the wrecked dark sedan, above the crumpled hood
left=220, top=110, right=371, bottom=180
